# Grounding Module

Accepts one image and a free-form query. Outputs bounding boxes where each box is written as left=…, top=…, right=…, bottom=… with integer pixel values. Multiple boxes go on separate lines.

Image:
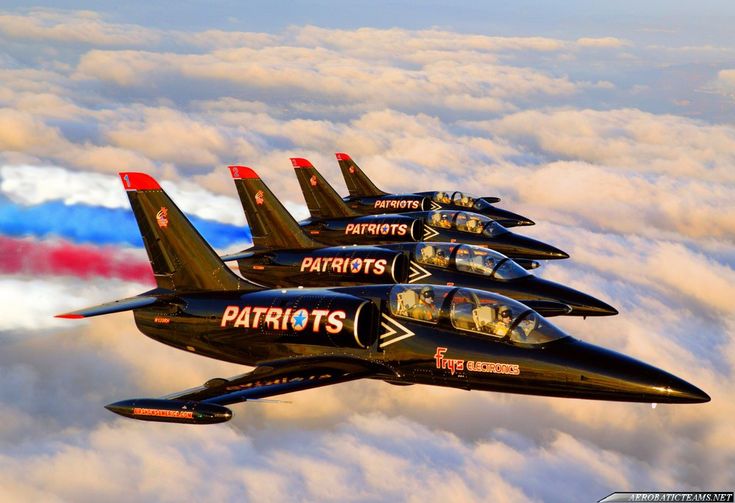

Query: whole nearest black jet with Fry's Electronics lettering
left=59, top=173, right=709, bottom=424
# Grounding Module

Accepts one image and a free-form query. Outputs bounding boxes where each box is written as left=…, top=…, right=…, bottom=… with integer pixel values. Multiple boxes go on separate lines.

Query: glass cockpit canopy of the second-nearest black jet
left=415, top=243, right=531, bottom=280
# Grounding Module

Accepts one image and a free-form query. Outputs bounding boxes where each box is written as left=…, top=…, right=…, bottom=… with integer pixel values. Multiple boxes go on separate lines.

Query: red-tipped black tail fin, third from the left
left=291, top=158, right=358, bottom=218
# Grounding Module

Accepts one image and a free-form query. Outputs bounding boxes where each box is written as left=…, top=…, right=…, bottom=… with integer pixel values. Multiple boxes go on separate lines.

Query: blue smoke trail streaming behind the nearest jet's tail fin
left=0, top=198, right=252, bottom=248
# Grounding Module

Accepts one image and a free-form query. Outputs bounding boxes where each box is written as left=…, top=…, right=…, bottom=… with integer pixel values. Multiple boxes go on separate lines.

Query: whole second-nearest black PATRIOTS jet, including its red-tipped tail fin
left=222, top=166, right=617, bottom=316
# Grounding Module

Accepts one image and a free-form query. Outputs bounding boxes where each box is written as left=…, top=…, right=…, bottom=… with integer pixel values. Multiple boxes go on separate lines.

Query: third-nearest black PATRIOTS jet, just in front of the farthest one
left=291, top=158, right=569, bottom=260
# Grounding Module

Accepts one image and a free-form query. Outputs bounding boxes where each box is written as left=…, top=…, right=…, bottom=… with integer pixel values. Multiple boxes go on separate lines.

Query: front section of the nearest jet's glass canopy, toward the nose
left=450, top=289, right=567, bottom=344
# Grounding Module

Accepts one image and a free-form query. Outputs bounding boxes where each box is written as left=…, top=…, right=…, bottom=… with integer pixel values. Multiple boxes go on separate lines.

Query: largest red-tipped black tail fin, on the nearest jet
left=120, top=173, right=249, bottom=291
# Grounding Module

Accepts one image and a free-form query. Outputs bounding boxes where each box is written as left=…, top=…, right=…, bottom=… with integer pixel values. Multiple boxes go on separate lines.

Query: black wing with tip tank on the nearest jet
left=106, top=356, right=400, bottom=424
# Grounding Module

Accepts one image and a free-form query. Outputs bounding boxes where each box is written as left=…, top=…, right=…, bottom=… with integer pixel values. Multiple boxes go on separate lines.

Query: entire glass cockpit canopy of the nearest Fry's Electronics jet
left=390, top=285, right=568, bottom=345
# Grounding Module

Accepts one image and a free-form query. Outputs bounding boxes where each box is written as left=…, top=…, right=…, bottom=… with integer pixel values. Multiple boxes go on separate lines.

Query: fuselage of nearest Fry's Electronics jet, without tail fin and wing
left=135, top=285, right=709, bottom=403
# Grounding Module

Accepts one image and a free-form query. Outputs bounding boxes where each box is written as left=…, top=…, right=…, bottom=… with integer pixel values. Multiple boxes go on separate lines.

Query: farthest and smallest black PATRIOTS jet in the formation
left=335, top=152, right=534, bottom=227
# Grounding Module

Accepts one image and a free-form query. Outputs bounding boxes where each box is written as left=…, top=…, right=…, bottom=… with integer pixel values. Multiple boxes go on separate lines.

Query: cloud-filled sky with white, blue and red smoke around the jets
left=0, top=0, right=735, bottom=502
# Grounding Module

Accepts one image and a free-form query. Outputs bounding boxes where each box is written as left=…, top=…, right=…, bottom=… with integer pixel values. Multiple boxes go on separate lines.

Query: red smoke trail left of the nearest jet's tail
left=0, top=236, right=155, bottom=285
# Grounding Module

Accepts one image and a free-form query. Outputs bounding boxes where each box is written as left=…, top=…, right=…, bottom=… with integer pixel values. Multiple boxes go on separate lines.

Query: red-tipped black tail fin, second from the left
left=230, top=166, right=324, bottom=249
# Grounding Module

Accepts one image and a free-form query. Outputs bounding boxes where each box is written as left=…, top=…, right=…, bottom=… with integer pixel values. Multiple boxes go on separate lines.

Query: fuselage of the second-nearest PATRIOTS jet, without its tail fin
left=230, top=243, right=617, bottom=316
